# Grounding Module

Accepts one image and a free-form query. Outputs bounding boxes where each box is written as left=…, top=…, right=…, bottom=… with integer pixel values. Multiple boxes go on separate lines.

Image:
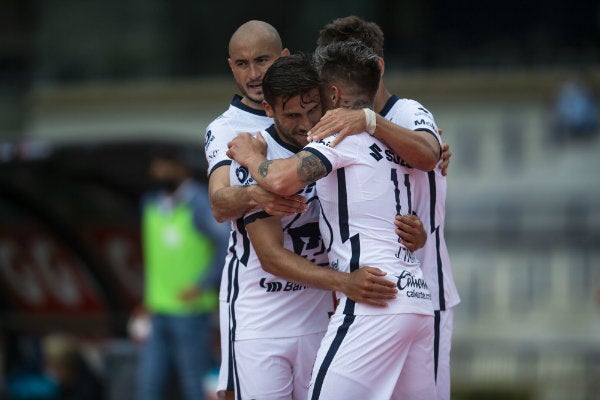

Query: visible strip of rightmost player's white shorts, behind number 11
left=434, top=308, right=454, bottom=400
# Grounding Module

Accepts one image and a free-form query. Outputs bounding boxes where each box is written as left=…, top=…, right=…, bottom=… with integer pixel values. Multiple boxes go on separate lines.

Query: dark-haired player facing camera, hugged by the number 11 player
left=230, top=54, right=410, bottom=400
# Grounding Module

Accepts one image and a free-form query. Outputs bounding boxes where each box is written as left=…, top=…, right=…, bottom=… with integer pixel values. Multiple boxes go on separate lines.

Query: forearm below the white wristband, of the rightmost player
left=374, top=115, right=440, bottom=171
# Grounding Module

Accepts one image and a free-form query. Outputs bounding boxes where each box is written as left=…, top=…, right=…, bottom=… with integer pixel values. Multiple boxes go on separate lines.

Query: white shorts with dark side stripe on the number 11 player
left=308, top=312, right=435, bottom=400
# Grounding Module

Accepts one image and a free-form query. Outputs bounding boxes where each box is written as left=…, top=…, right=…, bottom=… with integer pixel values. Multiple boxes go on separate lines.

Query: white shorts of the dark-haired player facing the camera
left=234, top=332, right=324, bottom=400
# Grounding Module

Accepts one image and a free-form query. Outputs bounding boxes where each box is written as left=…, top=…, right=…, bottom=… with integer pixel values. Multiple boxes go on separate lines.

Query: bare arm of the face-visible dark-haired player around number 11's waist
left=246, top=217, right=397, bottom=306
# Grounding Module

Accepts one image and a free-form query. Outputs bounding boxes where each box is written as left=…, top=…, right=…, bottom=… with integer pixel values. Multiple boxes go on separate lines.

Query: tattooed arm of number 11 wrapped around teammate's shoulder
left=227, top=133, right=327, bottom=197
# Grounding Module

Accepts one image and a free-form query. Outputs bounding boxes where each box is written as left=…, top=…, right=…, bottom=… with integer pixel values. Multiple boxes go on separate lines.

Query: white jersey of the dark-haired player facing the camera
left=229, top=126, right=333, bottom=341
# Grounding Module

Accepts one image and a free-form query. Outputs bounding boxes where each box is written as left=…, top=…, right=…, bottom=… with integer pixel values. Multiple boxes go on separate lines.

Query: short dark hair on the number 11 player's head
left=314, top=41, right=381, bottom=101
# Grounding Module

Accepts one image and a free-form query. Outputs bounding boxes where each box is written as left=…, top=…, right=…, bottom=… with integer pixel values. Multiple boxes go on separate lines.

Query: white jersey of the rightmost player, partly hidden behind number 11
left=380, top=96, right=460, bottom=311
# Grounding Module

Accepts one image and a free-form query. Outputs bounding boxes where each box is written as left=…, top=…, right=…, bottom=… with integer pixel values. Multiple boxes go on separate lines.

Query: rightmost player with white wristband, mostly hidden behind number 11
left=311, top=16, right=460, bottom=400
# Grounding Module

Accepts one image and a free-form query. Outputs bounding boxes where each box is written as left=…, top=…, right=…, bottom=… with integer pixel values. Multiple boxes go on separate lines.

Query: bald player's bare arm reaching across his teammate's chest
left=208, top=165, right=306, bottom=222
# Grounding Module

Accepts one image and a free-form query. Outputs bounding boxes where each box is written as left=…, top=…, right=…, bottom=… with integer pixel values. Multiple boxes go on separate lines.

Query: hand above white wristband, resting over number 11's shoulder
left=308, top=108, right=367, bottom=147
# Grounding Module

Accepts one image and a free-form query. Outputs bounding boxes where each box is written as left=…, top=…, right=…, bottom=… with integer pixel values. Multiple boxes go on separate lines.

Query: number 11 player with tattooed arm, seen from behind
left=228, top=42, right=437, bottom=399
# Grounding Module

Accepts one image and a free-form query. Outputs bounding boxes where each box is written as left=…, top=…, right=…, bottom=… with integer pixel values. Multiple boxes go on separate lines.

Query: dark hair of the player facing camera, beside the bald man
left=262, top=53, right=319, bottom=107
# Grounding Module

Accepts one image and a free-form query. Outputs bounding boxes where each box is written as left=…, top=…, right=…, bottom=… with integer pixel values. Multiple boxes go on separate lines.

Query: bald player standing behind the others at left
left=205, top=20, right=306, bottom=399
